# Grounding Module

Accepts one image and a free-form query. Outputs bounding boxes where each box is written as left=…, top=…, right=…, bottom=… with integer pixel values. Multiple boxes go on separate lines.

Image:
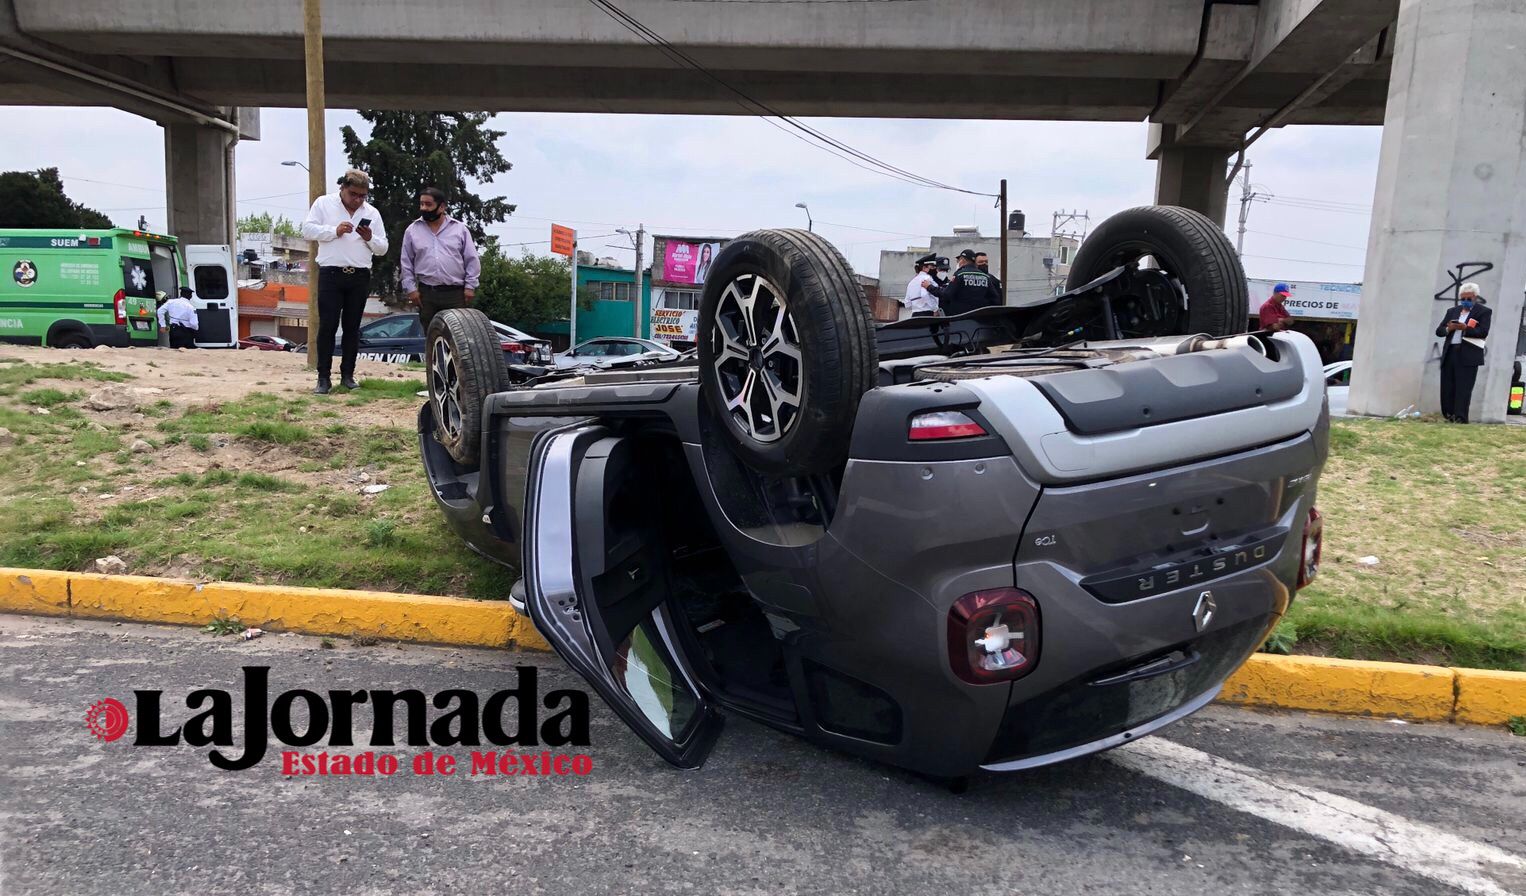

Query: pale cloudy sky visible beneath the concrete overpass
left=0, top=108, right=1381, bottom=282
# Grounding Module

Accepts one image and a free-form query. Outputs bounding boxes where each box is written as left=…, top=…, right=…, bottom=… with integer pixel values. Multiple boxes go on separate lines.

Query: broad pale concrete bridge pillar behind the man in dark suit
left=1351, top=0, right=1526, bottom=423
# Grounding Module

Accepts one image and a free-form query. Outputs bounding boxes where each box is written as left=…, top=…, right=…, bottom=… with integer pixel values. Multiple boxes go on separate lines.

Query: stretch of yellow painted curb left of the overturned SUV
left=0, top=568, right=551, bottom=650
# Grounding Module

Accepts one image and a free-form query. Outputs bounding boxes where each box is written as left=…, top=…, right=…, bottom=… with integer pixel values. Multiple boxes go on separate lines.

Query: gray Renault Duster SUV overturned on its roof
left=418, top=208, right=1329, bottom=778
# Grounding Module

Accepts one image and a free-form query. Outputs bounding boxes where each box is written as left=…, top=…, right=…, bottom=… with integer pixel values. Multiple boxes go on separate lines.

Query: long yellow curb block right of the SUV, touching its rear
left=1219, top=653, right=1456, bottom=722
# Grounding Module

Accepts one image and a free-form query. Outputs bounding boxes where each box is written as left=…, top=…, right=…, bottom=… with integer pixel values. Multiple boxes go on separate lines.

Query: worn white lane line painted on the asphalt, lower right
left=1106, top=737, right=1526, bottom=896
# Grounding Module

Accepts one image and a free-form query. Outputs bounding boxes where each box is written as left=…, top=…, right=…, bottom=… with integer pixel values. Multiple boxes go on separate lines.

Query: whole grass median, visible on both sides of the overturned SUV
left=0, top=353, right=1526, bottom=670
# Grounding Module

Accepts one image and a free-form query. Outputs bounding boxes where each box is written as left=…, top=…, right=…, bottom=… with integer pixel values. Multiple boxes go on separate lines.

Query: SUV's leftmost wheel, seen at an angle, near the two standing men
left=424, top=308, right=508, bottom=467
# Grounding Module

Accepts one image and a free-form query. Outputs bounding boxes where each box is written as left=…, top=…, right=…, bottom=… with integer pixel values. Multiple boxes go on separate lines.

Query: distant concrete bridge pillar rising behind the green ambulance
left=163, top=122, right=238, bottom=246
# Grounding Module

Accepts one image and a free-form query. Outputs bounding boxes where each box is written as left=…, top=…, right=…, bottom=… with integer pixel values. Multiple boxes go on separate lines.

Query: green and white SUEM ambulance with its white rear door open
left=0, top=229, right=238, bottom=348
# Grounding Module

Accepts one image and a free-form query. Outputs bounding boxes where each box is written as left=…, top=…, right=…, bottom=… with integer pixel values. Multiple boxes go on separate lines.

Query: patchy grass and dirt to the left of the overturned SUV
left=0, top=353, right=513, bottom=598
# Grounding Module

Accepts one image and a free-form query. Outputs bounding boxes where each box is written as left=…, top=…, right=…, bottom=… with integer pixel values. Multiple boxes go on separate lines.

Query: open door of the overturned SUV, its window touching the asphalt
left=523, top=423, right=722, bottom=768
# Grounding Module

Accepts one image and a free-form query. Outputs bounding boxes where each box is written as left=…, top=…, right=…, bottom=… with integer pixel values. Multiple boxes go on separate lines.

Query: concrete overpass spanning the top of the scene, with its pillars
left=0, top=0, right=1526, bottom=421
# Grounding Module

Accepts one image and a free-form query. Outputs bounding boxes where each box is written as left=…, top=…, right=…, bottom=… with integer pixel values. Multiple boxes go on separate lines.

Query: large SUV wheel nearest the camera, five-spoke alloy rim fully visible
left=699, top=230, right=879, bottom=475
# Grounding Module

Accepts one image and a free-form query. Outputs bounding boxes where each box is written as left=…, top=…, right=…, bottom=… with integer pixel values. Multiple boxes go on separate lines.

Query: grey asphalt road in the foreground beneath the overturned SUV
left=0, top=617, right=1526, bottom=896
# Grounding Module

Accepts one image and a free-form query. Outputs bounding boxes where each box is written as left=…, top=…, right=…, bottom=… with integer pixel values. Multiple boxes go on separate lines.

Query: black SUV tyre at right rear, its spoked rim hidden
left=1065, top=206, right=1250, bottom=339
